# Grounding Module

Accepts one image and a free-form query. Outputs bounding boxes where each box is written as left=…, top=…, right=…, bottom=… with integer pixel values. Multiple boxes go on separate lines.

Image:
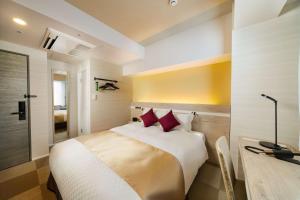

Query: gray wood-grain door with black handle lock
left=0, top=50, right=30, bottom=170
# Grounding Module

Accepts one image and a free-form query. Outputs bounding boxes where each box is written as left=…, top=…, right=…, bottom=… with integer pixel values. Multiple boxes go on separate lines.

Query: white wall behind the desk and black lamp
left=230, top=8, right=300, bottom=178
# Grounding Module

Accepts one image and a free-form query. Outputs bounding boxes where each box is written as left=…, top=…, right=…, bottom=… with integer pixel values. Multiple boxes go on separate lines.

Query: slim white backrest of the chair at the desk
left=216, top=136, right=235, bottom=200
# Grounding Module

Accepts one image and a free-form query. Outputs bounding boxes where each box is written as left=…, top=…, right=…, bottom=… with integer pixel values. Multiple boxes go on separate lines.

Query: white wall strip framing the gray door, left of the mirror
left=0, top=41, right=50, bottom=159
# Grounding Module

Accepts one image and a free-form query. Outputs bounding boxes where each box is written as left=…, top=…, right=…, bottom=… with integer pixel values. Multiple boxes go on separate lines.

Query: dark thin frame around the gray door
left=0, top=49, right=32, bottom=162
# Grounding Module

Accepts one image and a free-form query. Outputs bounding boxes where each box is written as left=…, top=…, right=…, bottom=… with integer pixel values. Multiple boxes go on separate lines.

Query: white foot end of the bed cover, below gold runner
left=49, top=139, right=141, bottom=200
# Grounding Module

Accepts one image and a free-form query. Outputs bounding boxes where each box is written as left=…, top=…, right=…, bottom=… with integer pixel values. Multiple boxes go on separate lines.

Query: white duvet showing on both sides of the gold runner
left=49, top=123, right=208, bottom=200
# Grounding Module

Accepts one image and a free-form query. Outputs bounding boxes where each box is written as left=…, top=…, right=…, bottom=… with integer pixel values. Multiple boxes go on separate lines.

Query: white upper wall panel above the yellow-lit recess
left=123, top=14, right=232, bottom=75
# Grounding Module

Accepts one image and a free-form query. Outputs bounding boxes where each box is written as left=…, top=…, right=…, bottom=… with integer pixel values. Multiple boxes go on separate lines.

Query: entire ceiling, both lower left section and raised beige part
left=0, top=0, right=232, bottom=65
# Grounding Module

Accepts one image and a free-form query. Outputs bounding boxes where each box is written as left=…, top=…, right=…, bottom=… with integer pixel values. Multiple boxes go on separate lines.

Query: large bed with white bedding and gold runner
left=49, top=122, right=208, bottom=200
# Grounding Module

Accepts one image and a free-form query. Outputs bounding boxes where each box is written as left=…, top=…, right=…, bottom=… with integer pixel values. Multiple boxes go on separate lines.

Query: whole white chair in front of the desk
left=216, top=136, right=247, bottom=200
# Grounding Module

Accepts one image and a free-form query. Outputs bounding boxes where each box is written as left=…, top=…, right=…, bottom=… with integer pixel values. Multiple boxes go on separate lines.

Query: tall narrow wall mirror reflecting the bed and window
left=52, top=71, right=69, bottom=143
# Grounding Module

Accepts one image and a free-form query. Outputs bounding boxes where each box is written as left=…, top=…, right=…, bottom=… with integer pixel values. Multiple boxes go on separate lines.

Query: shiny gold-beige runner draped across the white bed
left=76, top=131, right=184, bottom=200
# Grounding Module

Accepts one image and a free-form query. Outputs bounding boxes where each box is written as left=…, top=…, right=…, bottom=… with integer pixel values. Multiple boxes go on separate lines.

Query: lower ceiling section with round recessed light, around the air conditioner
left=0, top=0, right=136, bottom=65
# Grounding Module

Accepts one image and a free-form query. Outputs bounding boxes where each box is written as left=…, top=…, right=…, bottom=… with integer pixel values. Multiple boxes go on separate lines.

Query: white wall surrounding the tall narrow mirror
left=48, top=59, right=78, bottom=145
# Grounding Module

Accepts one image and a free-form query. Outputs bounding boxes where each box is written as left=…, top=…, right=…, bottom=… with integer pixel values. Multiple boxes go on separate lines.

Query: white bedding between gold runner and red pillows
left=111, top=122, right=208, bottom=193
